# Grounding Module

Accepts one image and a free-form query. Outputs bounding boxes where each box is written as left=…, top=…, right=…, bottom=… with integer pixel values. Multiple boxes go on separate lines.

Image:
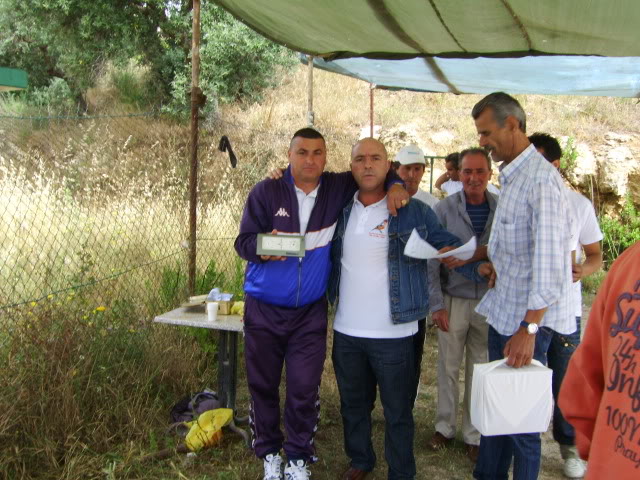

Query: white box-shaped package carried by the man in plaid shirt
left=471, top=359, right=553, bottom=436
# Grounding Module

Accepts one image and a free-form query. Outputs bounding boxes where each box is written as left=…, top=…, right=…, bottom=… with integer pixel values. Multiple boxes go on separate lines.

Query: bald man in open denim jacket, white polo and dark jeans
left=328, top=138, right=489, bottom=480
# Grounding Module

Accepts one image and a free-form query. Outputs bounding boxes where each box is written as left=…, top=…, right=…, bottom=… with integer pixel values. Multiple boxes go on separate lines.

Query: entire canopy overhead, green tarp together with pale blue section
left=217, top=0, right=640, bottom=97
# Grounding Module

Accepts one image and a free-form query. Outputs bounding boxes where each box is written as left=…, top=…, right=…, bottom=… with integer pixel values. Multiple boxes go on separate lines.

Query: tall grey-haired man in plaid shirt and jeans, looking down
left=472, top=92, right=576, bottom=480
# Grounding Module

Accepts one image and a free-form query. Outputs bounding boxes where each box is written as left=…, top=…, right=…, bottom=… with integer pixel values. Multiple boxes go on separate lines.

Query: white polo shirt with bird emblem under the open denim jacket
left=333, top=193, right=418, bottom=338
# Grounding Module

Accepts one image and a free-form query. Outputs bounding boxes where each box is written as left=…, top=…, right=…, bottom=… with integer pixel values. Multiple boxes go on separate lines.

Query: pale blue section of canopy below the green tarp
left=302, top=56, right=640, bottom=97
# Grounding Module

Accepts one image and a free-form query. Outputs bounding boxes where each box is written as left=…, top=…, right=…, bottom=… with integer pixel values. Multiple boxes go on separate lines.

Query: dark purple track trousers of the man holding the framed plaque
left=244, top=295, right=327, bottom=462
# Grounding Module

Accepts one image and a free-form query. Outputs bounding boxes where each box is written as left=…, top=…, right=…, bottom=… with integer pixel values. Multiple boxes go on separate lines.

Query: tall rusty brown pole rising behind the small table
left=188, top=0, right=202, bottom=295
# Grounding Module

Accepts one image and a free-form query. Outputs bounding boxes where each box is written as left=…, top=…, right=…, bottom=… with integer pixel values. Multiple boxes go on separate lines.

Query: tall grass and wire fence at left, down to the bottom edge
left=0, top=107, right=436, bottom=478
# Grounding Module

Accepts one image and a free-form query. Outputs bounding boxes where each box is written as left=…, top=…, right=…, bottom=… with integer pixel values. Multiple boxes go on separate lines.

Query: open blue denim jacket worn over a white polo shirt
left=327, top=200, right=486, bottom=323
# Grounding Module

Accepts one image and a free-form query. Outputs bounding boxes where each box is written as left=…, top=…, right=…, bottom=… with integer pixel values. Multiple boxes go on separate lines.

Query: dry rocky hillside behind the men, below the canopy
left=219, top=67, right=640, bottom=213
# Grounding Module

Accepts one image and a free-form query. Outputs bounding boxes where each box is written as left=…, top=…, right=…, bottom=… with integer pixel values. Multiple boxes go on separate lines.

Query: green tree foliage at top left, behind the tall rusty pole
left=0, top=0, right=293, bottom=108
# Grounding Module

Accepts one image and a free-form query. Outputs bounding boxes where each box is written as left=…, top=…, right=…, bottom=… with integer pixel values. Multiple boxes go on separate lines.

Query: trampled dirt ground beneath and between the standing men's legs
left=182, top=298, right=592, bottom=480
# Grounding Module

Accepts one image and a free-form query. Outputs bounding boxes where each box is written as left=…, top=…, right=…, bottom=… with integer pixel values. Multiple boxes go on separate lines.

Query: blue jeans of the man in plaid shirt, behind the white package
left=473, top=326, right=553, bottom=480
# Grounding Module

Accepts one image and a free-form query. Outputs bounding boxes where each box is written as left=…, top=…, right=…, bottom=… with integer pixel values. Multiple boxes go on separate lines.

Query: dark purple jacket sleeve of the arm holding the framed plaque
left=234, top=180, right=274, bottom=263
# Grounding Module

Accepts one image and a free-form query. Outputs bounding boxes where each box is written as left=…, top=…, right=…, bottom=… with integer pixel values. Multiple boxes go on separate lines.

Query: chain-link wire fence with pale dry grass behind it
left=0, top=113, right=354, bottom=322
